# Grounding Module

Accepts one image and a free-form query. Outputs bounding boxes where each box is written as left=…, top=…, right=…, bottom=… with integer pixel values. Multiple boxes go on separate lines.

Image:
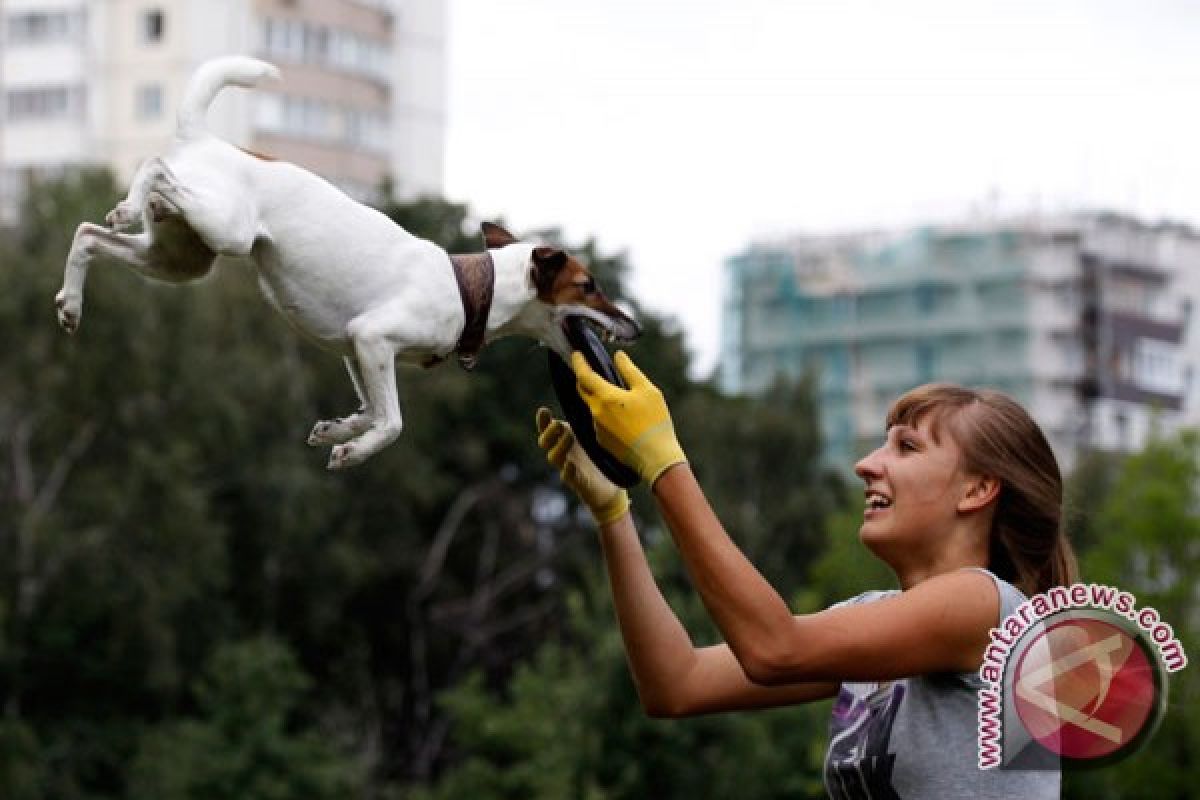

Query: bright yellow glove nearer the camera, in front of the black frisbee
left=571, top=350, right=688, bottom=488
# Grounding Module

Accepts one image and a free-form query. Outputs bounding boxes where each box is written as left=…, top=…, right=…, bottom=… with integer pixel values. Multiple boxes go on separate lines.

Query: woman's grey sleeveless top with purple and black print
left=824, top=570, right=1061, bottom=800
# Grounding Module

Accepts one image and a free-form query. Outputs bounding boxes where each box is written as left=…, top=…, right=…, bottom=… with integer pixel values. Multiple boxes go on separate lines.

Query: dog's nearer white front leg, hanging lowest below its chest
left=328, top=308, right=403, bottom=469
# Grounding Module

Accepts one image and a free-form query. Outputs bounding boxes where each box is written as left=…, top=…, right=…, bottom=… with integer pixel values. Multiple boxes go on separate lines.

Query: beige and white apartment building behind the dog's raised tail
left=0, top=0, right=446, bottom=221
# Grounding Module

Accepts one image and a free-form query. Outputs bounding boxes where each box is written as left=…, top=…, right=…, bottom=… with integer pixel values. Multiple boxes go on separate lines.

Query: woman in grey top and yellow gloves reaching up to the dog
left=538, top=353, right=1075, bottom=799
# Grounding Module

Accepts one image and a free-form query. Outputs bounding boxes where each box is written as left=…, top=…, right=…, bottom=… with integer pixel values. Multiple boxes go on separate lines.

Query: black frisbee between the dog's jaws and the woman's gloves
left=546, top=317, right=641, bottom=489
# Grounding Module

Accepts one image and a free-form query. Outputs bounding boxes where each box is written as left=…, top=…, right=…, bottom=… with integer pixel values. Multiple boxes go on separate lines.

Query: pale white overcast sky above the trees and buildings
left=446, top=0, right=1200, bottom=375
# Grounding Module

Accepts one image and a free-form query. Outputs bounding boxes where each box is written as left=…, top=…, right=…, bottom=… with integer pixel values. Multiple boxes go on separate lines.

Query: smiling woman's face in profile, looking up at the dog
left=854, top=415, right=964, bottom=563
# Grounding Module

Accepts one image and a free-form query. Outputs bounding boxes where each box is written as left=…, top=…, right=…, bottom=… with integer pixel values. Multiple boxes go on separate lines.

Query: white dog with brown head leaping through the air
left=55, top=56, right=638, bottom=469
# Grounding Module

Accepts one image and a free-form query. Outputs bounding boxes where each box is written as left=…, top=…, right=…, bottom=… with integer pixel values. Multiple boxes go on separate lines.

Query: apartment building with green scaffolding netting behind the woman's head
left=720, top=213, right=1200, bottom=467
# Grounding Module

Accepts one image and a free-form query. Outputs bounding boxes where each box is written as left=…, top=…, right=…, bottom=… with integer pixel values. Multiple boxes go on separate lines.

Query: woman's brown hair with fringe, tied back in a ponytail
left=887, top=384, right=1079, bottom=596
